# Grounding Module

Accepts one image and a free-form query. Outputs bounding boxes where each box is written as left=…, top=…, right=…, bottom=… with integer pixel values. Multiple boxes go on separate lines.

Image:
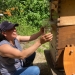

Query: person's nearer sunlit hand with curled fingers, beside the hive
left=40, top=33, right=53, bottom=44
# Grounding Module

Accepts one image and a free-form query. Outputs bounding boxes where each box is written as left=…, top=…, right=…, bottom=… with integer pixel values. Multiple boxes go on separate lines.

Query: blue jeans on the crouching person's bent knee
left=13, top=66, right=40, bottom=75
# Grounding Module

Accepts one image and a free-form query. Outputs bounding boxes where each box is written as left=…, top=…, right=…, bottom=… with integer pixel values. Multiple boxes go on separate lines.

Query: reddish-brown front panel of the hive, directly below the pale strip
left=56, top=26, right=75, bottom=49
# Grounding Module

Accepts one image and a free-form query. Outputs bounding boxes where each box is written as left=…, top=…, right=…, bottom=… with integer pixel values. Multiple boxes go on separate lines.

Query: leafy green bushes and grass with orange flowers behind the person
left=0, top=0, right=50, bottom=35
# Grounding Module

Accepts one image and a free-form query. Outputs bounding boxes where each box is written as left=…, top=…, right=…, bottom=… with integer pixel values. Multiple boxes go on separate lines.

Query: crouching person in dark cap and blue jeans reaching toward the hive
left=0, top=21, right=53, bottom=75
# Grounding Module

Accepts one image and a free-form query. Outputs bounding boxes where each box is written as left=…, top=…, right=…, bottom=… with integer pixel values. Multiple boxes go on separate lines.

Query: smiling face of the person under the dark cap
left=3, top=27, right=17, bottom=39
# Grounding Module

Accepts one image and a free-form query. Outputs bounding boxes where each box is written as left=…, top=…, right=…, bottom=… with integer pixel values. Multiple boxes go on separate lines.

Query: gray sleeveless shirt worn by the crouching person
left=0, top=39, right=22, bottom=75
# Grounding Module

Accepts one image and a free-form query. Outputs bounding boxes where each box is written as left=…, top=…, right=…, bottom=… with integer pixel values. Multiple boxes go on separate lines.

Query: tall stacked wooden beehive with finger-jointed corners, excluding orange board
left=50, top=0, right=75, bottom=68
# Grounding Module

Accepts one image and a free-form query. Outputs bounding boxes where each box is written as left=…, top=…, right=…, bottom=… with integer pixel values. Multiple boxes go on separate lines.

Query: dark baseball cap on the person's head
left=0, top=21, right=19, bottom=31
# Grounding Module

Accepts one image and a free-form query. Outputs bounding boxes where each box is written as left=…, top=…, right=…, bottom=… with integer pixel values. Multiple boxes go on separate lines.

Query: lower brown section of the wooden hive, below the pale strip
left=50, top=25, right=75, bottom=68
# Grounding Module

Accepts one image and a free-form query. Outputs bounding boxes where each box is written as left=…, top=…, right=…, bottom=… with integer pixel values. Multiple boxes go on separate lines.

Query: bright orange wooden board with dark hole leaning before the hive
left=63, top=45, right=75, bottom=75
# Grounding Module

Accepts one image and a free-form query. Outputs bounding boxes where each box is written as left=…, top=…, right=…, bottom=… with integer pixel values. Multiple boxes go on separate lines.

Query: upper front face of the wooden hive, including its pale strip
left=57, top=0, right=75, bottom=26
